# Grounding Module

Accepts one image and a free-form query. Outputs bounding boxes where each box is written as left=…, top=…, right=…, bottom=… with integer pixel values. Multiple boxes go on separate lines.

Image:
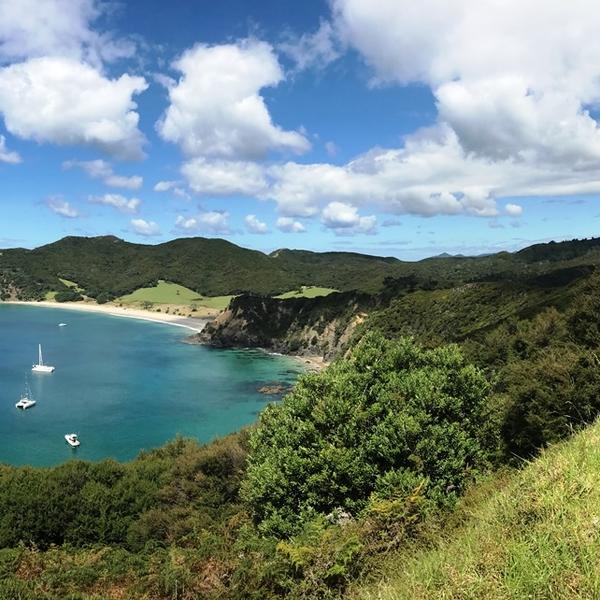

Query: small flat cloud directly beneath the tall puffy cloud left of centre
left=181, top=158, right=267, bottom=196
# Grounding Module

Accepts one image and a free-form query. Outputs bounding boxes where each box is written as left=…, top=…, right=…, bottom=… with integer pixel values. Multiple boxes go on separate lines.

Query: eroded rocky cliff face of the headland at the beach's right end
left=194, top=292, right=373, bottom=359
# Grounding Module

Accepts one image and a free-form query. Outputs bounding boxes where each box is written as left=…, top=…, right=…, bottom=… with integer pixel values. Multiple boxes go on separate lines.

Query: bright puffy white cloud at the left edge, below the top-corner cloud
left=0, top=57, right=147, bottom=159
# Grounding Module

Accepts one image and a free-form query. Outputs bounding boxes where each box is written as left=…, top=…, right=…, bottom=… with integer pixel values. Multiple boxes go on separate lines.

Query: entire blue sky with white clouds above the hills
left=0, top=0, right=600, bottom=260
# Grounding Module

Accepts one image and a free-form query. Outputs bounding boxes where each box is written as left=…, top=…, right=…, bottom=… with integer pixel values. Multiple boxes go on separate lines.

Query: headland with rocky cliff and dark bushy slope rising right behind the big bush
left=197, top=265, right=595, bottom=358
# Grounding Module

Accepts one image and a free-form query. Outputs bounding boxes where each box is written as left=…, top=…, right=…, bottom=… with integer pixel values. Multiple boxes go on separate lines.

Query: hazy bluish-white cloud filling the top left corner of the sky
left=0, top=0, right=135, bottom=66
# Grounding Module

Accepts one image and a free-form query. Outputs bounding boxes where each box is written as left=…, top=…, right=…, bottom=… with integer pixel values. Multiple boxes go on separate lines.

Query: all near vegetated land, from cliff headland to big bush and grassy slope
left=0, top=234, right=600, bottom=600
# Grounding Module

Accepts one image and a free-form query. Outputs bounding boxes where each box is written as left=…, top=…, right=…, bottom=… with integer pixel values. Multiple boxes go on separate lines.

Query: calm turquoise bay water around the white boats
left=0, top=305, right=301, bottom=465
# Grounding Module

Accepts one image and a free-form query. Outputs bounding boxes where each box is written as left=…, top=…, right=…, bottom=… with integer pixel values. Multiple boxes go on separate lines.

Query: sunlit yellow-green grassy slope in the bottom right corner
left=350, top=423, right=600, bottom=600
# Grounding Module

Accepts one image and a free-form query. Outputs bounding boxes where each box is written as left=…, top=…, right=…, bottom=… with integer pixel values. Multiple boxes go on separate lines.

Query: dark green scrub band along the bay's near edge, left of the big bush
left=0, top=433, right=246, bottom=549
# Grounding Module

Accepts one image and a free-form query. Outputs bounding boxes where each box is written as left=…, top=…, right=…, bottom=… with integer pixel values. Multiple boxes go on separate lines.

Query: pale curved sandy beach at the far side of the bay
left=0, top=300, right=211, bottom=333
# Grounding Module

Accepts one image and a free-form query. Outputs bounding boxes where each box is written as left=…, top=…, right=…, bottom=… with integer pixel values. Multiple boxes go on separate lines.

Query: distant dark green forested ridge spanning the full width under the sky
left=0, top=235, right=600, bottom=299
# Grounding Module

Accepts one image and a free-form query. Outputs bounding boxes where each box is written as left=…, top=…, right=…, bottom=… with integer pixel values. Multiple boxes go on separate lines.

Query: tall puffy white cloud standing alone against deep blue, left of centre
left=157, top=39, right=310, bottom=159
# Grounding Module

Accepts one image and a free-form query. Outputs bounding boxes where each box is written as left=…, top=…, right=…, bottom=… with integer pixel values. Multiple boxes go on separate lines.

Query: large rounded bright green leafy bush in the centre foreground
left=243, top=334, right=489, bottom=536
